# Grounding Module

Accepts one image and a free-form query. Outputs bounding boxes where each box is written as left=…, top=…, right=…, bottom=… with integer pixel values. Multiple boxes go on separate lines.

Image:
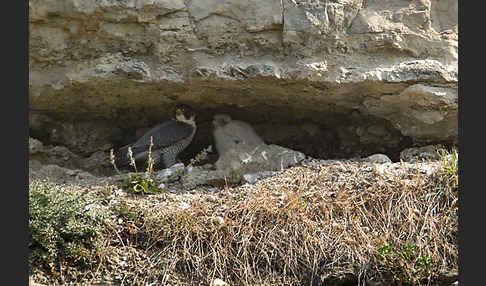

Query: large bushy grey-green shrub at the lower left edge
left=28, top=182, right=102, bottom=273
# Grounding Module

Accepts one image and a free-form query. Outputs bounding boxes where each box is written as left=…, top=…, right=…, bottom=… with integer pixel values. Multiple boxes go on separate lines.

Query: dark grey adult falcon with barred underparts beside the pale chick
left=116, top=104, right=197, bottom=168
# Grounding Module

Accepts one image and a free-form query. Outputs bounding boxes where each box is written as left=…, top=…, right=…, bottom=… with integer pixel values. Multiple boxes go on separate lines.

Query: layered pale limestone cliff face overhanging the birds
left=29, top=0, right=458, bottom=164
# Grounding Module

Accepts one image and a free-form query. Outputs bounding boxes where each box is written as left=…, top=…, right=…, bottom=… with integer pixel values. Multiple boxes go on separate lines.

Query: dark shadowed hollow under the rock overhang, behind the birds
left=30, top=104, right=430, bottom=178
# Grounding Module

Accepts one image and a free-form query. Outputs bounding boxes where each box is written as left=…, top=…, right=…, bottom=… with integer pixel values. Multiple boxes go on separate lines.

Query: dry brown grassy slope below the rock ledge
left=28, top=158, right=458, bottom=285
